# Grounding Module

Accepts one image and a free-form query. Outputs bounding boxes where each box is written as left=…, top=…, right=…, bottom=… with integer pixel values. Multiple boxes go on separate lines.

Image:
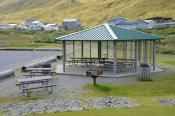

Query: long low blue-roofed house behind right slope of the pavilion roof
left=116, top=20, right=148, bottom=30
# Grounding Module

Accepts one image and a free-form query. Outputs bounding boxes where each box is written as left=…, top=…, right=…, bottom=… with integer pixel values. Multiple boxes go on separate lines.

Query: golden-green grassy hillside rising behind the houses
left=0, top=0, right=175, bottom=26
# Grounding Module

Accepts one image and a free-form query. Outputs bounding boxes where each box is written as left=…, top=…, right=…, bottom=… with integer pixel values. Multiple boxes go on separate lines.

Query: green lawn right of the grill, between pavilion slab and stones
left=86, top=72, right=175, bottom=97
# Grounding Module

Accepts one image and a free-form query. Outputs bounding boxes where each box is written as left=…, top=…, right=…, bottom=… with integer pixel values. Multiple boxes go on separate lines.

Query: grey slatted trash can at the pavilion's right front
left=139, top=63, right=151, bottom=81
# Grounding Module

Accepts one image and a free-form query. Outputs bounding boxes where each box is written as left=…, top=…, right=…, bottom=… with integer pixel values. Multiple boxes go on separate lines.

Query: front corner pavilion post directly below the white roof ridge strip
left=113, top=41, right=117, bottom=74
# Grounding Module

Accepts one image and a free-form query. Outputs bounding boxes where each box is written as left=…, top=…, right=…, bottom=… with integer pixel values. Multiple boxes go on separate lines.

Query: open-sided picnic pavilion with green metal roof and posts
left=56, top=24, right=163, bottom=74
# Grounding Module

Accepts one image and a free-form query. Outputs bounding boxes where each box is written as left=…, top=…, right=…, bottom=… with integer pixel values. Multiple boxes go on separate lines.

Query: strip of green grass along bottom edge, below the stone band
left=27, top=106, right=175, bottom=116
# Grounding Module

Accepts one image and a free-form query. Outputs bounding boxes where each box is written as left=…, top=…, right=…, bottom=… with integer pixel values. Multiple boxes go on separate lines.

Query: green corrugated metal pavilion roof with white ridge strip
left=56, top=24, right=163, bottom=41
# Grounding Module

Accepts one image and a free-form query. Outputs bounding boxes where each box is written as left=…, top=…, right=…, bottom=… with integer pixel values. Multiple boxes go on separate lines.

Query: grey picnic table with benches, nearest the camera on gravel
left=16, top=76, right=56, bottom=95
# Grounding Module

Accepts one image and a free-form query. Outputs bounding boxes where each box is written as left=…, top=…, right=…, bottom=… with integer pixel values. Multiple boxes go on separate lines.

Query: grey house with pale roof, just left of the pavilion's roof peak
left=63, top=19, right=82, bottom=30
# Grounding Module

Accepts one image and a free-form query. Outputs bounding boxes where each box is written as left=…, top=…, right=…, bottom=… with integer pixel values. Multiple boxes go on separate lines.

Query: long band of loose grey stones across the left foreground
left=0, top=97, right=139, bottom=116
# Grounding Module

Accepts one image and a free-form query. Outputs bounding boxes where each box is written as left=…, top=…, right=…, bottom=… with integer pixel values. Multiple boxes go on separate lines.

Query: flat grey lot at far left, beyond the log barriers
left=0, top=51, right=59, bottom=71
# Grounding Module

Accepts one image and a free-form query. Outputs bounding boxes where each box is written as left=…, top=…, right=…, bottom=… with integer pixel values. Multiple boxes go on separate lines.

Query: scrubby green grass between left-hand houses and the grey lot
left=0, top=29, right=66, bottom=45
